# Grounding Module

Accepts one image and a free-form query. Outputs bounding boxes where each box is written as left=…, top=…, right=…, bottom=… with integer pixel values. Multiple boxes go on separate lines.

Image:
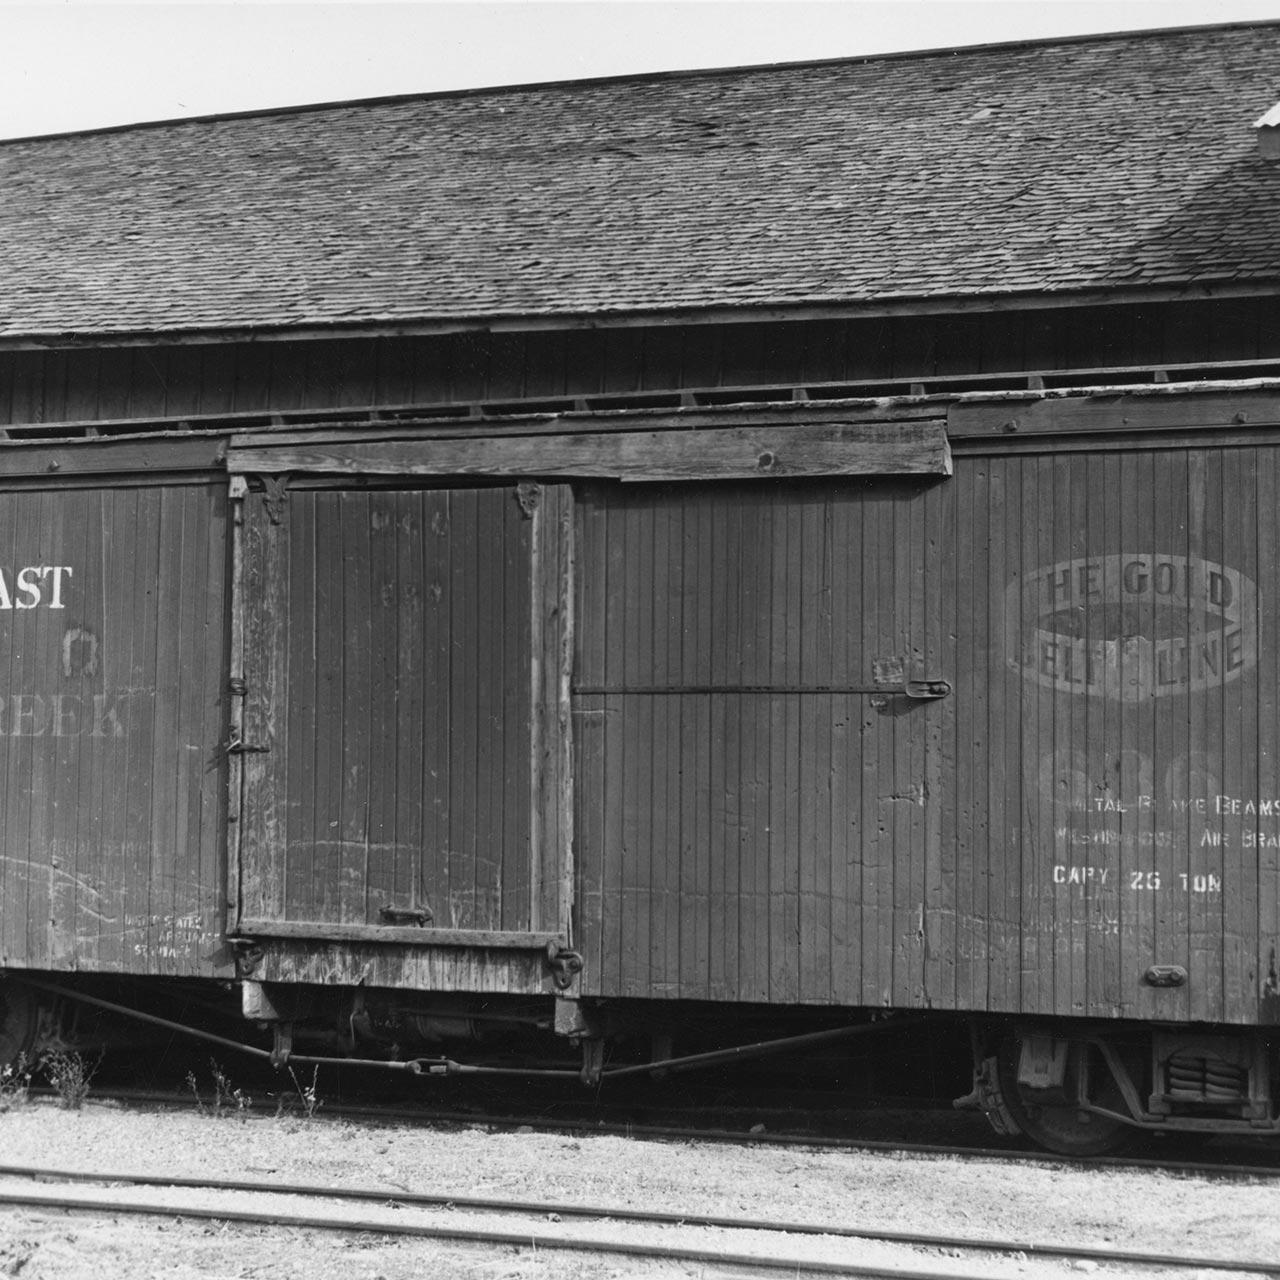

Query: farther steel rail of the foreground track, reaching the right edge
left=0, top=1164, right=1280, bottom=1275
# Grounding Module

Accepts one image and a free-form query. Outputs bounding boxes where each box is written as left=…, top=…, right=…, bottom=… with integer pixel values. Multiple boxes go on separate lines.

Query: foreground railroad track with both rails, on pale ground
left=0, top=1165, right=1280, bottom=1280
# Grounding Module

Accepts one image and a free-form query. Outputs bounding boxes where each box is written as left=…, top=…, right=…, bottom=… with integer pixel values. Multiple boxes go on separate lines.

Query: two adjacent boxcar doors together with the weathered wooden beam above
left=228, top=404, right=951, bottom=1002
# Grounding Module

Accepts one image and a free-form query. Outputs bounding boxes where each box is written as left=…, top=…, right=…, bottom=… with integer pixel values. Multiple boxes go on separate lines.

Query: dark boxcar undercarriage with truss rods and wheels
left=0, top=974, right=1280, bottom=1156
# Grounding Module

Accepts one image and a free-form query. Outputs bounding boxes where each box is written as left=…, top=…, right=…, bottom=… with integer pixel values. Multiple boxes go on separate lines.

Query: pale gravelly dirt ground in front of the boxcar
left=0, top=1098, right=1280, bottom=1280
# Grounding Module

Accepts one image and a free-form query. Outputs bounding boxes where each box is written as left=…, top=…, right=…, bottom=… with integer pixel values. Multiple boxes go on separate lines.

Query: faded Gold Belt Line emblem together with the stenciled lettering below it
left=1004, top=550, right=1264, bottom=933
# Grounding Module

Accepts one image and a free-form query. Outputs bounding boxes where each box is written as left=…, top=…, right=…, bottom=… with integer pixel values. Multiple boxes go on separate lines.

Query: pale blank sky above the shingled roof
left=0, top=0, right=1280, bottom=138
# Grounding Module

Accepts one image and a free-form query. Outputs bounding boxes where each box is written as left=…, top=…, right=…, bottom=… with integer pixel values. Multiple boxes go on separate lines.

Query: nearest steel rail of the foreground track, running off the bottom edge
left=0, top=1189, right=1039, bottom=1280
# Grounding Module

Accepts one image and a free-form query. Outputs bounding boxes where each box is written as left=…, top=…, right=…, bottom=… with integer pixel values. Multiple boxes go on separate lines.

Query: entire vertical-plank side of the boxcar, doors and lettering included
left=0, top=386, right=1280, bottom=1023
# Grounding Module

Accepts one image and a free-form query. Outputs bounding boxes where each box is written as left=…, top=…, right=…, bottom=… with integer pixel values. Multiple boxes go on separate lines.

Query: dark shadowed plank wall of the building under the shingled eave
left=0, top=298, right=1280, bottom=424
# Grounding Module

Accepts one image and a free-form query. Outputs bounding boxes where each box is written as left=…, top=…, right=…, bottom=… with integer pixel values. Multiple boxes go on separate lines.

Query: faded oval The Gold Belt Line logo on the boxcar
left=1005, top=552, right=1258, bottom=703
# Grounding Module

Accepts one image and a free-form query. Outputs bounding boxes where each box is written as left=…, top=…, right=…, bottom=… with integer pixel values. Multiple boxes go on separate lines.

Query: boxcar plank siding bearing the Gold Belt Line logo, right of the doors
left=931, top=448, right=1280, bottom=1021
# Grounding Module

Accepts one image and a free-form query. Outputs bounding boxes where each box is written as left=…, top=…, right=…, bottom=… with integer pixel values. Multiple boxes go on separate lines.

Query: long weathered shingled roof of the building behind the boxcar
left=0, top=23, right=1280, bottom=339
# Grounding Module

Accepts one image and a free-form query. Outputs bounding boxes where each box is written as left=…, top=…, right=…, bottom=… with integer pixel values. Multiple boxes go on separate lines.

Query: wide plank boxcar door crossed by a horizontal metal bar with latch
left=575, top=480, right=947, bottom=1005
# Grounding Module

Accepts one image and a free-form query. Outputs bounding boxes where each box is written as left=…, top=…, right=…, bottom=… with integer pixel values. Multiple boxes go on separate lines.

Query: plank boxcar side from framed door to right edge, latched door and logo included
left=573, top=435, right=1280, bottom=1023
